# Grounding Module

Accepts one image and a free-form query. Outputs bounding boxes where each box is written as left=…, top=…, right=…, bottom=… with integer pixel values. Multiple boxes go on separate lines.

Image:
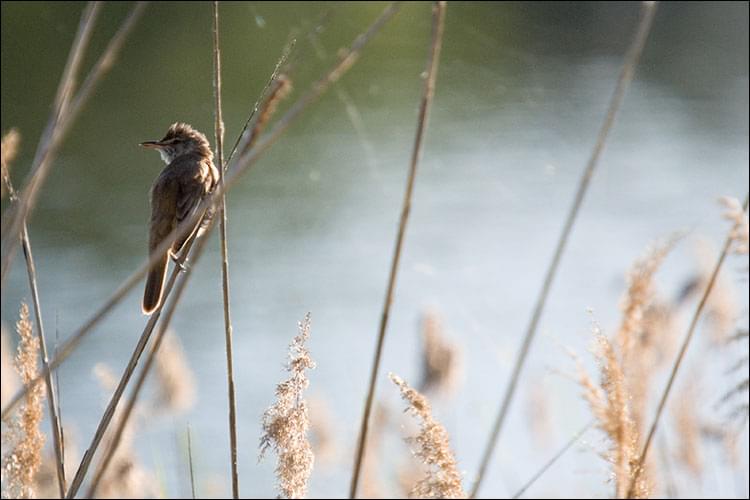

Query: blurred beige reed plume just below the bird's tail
left=154, top=331, right=195, bottom=413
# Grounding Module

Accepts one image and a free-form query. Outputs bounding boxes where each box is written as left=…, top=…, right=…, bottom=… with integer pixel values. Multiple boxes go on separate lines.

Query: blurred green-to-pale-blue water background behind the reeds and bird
left=1, top=2, right=748, bottom=497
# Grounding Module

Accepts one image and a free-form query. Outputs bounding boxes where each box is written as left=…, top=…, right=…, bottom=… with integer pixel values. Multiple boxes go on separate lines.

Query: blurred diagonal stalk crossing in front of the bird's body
left=2, top=7, right=398, bottom=418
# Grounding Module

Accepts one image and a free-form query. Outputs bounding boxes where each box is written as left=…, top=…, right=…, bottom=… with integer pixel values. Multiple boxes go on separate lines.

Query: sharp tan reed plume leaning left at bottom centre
left=389, top=373, right=466, bottom=498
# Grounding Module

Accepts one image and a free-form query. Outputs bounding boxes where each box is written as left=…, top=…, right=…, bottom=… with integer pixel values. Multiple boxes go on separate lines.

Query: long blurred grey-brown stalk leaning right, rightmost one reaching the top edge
left=471, top=2, right=656, bottom=498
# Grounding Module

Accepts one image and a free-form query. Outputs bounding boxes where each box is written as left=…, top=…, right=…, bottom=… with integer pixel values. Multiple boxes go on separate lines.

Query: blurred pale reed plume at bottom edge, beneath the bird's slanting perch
left=94, top=363, right=159, bottom=498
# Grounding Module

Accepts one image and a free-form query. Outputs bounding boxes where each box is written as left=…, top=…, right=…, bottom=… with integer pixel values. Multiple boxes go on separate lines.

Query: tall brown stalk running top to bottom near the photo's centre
left=349, top=2, right=446, bottom=498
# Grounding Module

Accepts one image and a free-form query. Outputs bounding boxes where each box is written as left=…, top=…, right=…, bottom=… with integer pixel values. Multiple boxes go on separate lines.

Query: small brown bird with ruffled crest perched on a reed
left=141, top=123, right=219, bottom=314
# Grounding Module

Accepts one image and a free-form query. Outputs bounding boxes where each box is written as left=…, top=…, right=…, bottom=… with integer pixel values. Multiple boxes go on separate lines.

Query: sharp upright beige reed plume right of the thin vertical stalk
left=260, top=313, right=315, bottom=498
